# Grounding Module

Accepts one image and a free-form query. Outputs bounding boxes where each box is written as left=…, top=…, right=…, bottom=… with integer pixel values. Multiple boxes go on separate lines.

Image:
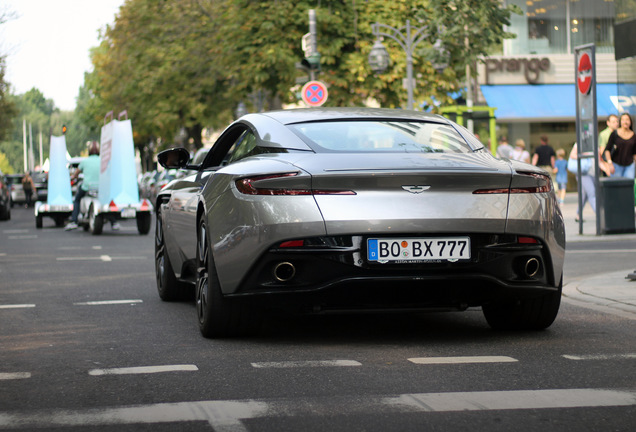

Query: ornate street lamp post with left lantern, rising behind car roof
left=369, top=20, right=430, bottom=110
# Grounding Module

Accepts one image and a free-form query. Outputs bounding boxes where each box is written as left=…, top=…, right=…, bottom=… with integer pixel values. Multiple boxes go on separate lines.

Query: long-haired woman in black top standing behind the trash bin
left=605, top=113, right=636, bottom=179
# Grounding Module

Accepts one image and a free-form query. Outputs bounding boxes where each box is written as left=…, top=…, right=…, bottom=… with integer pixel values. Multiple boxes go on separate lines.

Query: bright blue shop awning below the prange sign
left=480, top=84, right=631, bottom=122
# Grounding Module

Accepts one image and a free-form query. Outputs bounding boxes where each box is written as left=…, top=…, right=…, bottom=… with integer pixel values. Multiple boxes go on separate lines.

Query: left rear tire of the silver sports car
left=195, top=217, right=261, bottom=338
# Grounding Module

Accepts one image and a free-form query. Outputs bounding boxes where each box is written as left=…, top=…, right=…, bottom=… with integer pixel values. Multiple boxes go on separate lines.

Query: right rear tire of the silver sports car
left=482, top=277, right=563, bottom=330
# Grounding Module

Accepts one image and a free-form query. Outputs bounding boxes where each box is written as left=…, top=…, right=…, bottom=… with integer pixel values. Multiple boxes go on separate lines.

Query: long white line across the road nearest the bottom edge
left=0, top=389, right=636, bottom=432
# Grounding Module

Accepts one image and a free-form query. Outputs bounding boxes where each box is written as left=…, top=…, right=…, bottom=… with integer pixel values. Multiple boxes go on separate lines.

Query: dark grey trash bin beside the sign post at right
left=600, top=177, right=636, bottom=234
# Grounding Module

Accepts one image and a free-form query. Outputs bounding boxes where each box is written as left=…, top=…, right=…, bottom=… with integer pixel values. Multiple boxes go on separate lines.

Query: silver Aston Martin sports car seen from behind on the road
left=155, top=108, right=565, bottom=337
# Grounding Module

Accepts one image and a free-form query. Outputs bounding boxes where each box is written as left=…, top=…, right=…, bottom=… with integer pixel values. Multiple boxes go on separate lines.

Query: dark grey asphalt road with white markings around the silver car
left=0, top=208, right=636, bottom=432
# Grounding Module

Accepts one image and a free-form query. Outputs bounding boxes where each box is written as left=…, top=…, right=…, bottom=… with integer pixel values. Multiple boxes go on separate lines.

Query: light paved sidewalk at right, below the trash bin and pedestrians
left=561, top=193, right=636, bottom=320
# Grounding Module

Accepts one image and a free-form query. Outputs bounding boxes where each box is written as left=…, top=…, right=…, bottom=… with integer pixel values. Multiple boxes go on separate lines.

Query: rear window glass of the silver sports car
left=289, top=121, right=474, bottom=153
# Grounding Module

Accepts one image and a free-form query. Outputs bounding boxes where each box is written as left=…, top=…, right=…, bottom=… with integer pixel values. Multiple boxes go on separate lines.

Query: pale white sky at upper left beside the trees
left=0, top=0, right=125, bottom=111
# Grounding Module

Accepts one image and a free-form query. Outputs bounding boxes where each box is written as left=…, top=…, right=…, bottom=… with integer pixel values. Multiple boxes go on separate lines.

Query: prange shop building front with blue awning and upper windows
left=473, top=0, right=636, bottom=157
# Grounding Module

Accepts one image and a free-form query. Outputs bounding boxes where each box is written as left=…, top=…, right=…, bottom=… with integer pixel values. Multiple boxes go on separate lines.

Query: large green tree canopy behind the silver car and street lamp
left=76, top=0, right=514, bottom=157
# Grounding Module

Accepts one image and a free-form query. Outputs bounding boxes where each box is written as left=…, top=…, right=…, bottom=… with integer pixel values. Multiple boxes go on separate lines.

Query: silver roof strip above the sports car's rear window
left=261, top=107, right=448, bottom=125
